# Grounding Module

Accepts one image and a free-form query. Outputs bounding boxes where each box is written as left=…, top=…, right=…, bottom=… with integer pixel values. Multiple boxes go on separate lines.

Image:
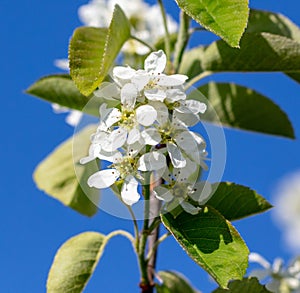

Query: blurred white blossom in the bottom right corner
left=249, top=253, right=300, bottom=293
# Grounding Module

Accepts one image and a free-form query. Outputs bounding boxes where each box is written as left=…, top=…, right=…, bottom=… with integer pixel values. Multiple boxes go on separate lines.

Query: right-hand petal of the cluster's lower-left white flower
left=138, top=151, right=167, bottom=171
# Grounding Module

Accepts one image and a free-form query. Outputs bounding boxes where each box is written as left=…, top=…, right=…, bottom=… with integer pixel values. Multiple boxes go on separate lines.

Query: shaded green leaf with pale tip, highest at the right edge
left=246, top=9, right=300, bottom=42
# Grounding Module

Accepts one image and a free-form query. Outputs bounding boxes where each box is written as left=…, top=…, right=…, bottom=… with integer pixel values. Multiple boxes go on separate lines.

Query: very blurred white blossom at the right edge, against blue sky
left=272, top=171, right=300, bottom=252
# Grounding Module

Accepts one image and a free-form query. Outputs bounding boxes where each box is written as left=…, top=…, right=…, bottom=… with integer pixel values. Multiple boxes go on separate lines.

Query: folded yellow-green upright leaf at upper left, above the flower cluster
left=69, top=5, right=130, bottom=96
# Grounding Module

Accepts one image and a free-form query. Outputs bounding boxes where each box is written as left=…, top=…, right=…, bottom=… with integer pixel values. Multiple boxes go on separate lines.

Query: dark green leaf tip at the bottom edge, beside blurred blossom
left=213, top=278, right=271, bottom=293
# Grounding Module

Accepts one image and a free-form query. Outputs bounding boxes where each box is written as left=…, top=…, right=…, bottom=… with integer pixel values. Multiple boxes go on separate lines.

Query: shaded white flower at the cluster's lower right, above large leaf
left=154, top=159, right=212, bottom=215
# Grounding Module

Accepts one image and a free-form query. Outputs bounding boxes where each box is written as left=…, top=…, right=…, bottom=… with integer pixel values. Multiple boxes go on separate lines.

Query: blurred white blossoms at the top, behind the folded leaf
left=78, top=0, right=177, bottom=55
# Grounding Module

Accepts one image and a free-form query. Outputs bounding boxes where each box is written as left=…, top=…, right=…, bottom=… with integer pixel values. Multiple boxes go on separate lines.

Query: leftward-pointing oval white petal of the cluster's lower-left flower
left=87, top=169, right=120, bottom=189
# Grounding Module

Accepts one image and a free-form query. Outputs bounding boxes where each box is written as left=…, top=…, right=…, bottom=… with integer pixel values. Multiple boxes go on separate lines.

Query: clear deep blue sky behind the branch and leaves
left=0, top=0, right=300, bottom=293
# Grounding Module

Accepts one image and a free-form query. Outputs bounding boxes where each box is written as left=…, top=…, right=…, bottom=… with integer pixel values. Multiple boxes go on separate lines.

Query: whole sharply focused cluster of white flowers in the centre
left=81, top=50, right=211, bottom=214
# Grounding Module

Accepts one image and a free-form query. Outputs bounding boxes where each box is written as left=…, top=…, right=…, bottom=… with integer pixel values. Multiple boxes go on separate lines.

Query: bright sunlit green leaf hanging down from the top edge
left=176, top=0, right=249, bottom=47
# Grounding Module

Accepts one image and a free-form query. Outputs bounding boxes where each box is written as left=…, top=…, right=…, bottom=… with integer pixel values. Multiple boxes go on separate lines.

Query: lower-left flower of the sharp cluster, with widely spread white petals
left=80, top=144, right=166, bottom=205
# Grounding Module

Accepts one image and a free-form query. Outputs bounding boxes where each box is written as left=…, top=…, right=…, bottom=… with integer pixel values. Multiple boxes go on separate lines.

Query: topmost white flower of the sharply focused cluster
left=113, top=50, right=188, bottom=103
